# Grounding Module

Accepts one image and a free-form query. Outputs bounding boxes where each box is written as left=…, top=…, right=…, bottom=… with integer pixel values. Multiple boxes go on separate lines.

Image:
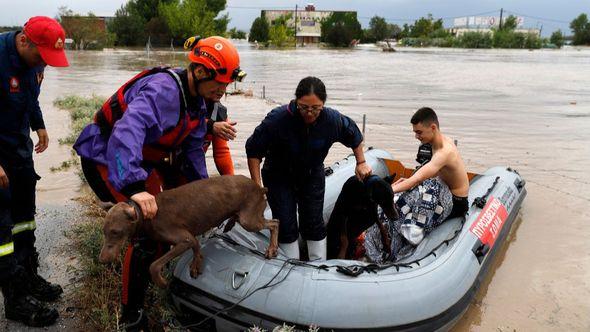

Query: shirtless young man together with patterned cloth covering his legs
left=364, top=107, right=469, bottom=264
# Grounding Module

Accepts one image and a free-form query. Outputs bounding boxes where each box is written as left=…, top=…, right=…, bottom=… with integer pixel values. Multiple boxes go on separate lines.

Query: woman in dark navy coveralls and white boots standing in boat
left=246, top=77, right=371, bottom=260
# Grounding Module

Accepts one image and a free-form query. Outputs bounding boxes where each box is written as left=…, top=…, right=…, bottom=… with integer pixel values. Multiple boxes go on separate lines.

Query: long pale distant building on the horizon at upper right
left=450, top=16, right=541, bottom=37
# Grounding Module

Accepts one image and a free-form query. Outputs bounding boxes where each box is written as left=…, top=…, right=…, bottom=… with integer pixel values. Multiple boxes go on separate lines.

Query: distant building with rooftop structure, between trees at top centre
left=261, top=4, right=356, bottom=45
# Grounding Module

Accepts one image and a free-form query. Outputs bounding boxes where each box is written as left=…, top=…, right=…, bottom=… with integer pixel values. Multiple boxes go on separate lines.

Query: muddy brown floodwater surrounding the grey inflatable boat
left=36, top=44, right=590, bottom=331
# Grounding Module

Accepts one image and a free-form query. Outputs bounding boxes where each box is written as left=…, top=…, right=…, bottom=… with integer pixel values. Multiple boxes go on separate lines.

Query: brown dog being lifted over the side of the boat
left=99, top=175, right=279, bottom=287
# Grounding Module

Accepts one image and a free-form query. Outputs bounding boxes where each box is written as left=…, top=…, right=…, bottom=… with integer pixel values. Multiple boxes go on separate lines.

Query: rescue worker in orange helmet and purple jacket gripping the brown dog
left=74, top=37, right=245, bottom=331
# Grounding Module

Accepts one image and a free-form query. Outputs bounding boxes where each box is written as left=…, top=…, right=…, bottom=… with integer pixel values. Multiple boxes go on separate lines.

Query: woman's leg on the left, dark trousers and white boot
left=262, top=170, right=299, bottom=259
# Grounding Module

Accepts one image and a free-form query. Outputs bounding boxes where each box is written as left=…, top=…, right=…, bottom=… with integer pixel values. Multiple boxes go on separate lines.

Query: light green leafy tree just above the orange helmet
left=158, top=0, right=229, bottom=40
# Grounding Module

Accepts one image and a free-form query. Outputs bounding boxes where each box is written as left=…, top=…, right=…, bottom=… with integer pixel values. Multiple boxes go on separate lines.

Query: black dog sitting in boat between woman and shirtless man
left=328, top=175, right=398, bottom=259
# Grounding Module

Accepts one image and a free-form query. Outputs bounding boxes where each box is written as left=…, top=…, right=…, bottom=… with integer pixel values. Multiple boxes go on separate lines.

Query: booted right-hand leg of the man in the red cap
left=10, top=167, right=63, bottom=301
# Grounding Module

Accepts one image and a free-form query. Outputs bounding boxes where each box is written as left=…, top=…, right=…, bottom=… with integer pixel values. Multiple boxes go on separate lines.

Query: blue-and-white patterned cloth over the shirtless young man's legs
left=364, top=178, right=453, bottom=264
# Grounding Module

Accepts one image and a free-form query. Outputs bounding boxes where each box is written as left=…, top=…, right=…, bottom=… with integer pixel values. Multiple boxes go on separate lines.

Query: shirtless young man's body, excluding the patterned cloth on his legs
left=392, top=107, right=469, bottom=218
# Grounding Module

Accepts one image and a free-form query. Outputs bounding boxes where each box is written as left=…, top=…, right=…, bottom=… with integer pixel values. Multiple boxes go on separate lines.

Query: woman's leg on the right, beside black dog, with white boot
left=297, top=169, right=327, bottom=261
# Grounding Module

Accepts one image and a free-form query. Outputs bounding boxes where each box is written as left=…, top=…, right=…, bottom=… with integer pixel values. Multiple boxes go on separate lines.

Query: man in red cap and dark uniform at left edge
left=0, top=16, right=68, bottom=326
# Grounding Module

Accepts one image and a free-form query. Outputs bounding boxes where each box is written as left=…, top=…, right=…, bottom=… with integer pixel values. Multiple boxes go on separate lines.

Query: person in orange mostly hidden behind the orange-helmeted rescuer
left=203, top=102, right=237, bottom=175
